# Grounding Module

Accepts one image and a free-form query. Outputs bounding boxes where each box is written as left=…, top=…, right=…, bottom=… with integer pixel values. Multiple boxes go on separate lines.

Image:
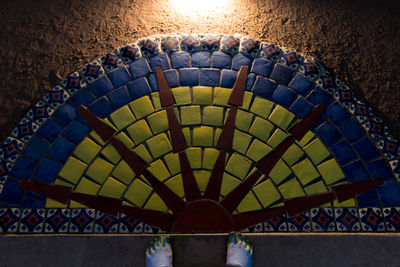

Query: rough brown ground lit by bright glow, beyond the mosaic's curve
left=0, top=0, right=400, bottom=142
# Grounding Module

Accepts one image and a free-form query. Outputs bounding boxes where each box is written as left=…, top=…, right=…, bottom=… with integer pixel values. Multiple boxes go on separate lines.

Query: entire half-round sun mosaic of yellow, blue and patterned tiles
left=0, top=34, right=400, bottom=234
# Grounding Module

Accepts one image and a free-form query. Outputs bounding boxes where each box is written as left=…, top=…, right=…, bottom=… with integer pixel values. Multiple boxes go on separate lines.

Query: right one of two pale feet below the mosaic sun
left=226, top=232, right=253, bottom=267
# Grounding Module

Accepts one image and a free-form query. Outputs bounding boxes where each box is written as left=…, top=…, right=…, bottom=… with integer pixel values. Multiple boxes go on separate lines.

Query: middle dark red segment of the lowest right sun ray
left=284, top=192, right=335, bottom=217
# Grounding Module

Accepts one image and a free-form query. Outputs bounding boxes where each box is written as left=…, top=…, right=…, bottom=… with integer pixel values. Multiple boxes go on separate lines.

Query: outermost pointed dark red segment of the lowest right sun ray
left=332, top=178, right=384, bottom=202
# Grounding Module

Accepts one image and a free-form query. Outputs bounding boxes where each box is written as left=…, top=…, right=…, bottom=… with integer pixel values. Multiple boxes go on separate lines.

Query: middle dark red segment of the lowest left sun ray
left=70, top=192, right=122, bottom=216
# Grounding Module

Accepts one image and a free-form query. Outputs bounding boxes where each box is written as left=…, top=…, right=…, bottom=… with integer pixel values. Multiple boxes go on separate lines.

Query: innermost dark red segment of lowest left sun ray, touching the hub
left=121, top=205, right=172, bottom=231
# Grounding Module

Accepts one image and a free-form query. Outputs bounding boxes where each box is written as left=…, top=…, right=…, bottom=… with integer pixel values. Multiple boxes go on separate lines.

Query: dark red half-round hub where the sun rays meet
left=171, top=199, right=236, bottom=233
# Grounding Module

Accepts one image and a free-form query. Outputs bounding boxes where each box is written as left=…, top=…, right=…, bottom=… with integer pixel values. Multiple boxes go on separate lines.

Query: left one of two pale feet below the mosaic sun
left=146, top=236, right=172, bottom=267
